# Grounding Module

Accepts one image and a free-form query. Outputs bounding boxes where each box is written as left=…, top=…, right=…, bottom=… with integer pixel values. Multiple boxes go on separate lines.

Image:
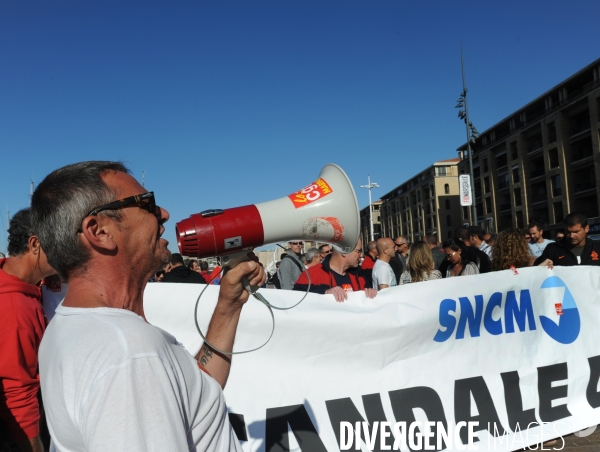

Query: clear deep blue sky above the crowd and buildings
left=0, top=0, right=600, bottom=251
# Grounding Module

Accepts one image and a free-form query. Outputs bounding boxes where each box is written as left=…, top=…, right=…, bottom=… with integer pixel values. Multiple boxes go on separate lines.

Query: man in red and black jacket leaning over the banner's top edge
left=294, top=239, right=377, bottom=303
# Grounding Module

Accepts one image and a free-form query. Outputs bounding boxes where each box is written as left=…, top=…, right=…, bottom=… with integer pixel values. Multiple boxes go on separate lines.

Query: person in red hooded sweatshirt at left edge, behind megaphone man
left=0, top=209, right=56, bottom=452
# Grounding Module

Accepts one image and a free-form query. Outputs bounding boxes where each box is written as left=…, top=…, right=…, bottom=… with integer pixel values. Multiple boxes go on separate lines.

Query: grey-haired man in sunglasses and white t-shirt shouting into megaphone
left=31, top=162, right=266, bottom=452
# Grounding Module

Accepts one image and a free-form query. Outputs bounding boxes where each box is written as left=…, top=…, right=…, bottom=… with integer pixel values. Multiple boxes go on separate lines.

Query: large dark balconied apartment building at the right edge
left=458, top=59, right=600, bottom=232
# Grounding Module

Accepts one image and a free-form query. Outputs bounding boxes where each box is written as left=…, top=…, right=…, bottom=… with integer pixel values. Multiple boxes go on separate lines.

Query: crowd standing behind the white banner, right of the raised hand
left=258, top=212, right=600, bottom=302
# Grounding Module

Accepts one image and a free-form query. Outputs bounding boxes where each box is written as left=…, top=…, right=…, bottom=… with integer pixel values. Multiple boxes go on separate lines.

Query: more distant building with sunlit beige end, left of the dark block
left=380, top=158, right=461, bottom=242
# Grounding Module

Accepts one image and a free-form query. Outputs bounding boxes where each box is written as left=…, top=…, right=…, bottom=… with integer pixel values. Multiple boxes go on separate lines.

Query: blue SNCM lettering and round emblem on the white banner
left=433, top=276, right=581, bottom=344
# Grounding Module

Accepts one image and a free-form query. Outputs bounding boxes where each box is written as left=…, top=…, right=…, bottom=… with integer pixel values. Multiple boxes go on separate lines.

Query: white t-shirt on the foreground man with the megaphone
left=39, top=305, right=242, bottom=452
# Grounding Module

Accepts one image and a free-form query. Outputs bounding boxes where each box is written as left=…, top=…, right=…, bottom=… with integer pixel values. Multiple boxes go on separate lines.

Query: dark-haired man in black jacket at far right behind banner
left=534, top=212, right=600, bottom=266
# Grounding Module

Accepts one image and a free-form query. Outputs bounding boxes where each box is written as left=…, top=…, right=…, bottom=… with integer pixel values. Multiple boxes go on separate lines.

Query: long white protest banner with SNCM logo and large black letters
left=144, top=267, right=600, bottom=452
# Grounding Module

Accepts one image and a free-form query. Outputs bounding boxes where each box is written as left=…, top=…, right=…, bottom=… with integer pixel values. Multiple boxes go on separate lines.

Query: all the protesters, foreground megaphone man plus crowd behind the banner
left=0, top=162, right=600, bottom=452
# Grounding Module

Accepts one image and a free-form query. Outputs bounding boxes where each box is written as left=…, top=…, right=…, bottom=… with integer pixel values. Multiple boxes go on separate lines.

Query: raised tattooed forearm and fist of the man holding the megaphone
left=196, top=253, right=267, bottom=387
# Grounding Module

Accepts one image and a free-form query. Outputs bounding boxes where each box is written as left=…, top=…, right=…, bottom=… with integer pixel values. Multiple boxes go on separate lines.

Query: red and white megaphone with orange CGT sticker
left=176, top=164, right=360, bottom=265
